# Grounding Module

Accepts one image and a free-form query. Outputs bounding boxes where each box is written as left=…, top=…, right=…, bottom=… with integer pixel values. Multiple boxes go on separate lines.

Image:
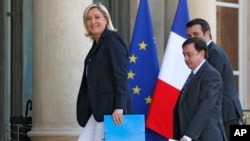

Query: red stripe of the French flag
left=146, top=79, right=180, bottom=138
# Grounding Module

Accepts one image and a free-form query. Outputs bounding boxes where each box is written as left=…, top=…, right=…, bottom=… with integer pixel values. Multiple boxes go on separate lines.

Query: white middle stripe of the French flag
left=158, top=31, right=190, bottom=90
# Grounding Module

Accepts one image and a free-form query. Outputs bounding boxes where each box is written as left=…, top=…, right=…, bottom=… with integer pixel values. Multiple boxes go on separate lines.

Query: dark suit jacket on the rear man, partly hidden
left=208, top=42, right=243, bottom=122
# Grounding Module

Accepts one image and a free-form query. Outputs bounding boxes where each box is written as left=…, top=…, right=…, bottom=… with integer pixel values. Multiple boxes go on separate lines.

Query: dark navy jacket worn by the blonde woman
left=77, top=29, right=133, bottom=127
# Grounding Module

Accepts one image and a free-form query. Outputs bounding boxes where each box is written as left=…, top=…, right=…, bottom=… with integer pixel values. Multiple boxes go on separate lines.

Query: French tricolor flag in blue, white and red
left=146, top=0, right=190, bottom=138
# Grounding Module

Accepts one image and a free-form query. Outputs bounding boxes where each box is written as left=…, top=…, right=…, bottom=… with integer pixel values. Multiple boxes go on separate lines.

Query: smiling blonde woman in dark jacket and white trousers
left=77, top=3, right=133, bottom=141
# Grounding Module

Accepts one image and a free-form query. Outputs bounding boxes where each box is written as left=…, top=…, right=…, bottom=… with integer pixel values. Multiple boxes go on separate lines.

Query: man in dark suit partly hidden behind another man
left=186, top=18, right=243, bottom=139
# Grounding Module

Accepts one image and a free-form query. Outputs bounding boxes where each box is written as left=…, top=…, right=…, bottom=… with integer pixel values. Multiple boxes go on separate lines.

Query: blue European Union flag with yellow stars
left=128, top=0, right=166, bottom=141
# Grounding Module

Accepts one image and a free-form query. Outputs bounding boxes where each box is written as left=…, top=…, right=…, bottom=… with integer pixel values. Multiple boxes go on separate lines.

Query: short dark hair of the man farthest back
left=186, top=18, right=212, bottom=39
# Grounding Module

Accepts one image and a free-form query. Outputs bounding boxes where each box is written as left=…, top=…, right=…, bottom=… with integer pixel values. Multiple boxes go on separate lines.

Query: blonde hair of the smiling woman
left=83, top=3, right=116, bottom=39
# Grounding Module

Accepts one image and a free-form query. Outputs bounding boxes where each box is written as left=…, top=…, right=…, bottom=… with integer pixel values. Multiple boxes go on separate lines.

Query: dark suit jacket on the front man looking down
left=174, top=61, right=226, bottom=141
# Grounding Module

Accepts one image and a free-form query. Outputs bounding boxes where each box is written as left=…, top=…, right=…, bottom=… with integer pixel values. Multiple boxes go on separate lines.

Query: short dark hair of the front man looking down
left=182, top=37, right=208, bottom=59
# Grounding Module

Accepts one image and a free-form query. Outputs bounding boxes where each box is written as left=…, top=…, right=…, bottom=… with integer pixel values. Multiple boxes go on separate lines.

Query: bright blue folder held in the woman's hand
left=104, top=115, right=145, bottom=141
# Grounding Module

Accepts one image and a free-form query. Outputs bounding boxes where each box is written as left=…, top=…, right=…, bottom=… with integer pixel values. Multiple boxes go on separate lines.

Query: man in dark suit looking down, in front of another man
left=174, top=37, right=227, bottom=141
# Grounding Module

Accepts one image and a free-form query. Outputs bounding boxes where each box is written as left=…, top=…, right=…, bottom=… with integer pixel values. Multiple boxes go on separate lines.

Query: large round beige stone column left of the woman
left=28, top=0, right=92, bottom=141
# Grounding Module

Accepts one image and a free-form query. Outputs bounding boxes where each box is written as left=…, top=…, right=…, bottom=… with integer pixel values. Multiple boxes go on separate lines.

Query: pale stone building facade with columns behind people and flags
left=0, top=0, right=250, bottom=141
